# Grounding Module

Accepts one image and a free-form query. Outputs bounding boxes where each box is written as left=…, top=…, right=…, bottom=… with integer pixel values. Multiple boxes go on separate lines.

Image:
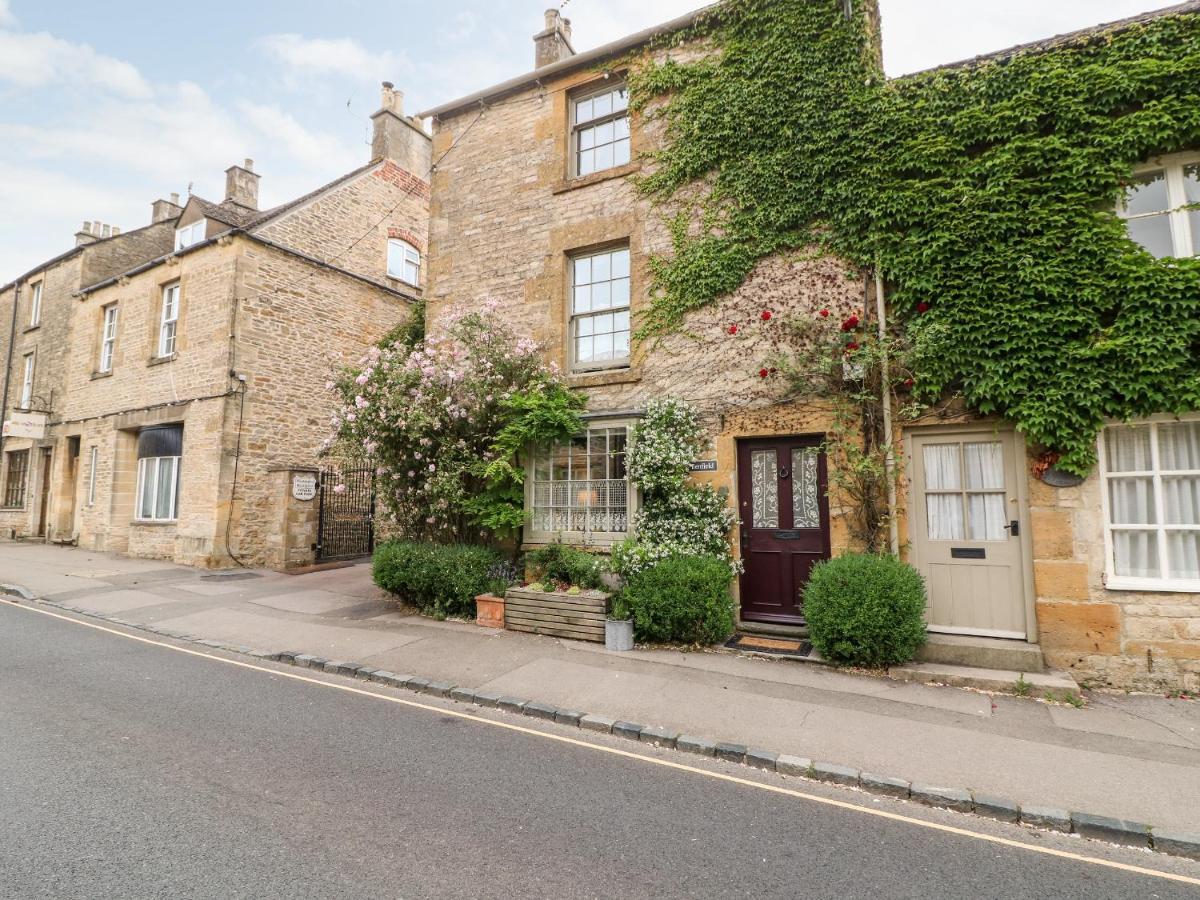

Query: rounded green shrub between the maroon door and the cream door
left=804, top=553, right=925, bottom=668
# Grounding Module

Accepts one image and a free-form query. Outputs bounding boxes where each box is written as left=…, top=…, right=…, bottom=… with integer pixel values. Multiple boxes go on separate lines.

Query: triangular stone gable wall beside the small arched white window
left=256, top=160, right=430, bottom=290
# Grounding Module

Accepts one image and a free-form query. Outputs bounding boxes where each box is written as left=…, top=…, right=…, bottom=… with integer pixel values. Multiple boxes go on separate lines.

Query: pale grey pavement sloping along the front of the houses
left=0, top=544, right=1200, bottom=833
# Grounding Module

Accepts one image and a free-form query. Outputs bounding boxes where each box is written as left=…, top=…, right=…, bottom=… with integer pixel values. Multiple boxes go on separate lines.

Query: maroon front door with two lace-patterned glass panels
left=738, top=434, right=829, bottom=625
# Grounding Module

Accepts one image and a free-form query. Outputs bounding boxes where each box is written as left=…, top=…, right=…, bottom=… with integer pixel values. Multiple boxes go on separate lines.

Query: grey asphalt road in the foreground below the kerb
left=0, top=602, right=1200, bottom=900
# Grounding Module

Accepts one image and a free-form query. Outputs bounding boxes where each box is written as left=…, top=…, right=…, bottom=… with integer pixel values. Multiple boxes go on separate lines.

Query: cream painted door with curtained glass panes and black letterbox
left=910, top=431, right=1027, bottom=638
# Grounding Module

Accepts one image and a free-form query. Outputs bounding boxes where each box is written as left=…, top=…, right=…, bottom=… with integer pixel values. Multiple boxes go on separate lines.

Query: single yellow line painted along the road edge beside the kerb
left=5, top=598, right=1200, bottom=887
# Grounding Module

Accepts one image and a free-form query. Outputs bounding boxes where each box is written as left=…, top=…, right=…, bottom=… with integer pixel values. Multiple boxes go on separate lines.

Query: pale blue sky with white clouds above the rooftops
left=0, top=0, right=1170, bottom=284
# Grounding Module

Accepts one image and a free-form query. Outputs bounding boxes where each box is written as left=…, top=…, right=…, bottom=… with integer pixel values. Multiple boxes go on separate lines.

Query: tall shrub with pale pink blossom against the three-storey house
left=325, top=301, right=586, bottom=541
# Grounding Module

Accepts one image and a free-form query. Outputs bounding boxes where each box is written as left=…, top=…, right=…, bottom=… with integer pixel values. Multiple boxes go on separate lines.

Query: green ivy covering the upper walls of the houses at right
left=630, top=0, right=1200, bottom=474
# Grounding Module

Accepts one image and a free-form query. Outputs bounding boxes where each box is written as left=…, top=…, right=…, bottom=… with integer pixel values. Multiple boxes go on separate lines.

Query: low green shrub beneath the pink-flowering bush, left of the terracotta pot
left=372, top=541, right=503, bottom=618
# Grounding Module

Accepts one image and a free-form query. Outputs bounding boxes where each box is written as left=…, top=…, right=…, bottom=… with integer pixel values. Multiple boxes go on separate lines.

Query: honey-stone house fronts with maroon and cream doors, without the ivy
left=421, top=4, right=1200, bottom=689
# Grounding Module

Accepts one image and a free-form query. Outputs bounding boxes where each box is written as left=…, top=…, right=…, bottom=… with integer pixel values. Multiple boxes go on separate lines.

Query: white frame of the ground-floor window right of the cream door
left=1098, top=415, right=1200, bottom=593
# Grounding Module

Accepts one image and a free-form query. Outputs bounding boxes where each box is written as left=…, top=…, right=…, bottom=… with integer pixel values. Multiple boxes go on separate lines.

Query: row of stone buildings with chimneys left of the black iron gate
left=0, top=84, right=431, bottom=568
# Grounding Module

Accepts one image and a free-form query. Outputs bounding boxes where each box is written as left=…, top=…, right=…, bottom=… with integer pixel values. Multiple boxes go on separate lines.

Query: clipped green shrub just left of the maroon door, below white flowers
left=613, top=556, right=733, bottom=643
